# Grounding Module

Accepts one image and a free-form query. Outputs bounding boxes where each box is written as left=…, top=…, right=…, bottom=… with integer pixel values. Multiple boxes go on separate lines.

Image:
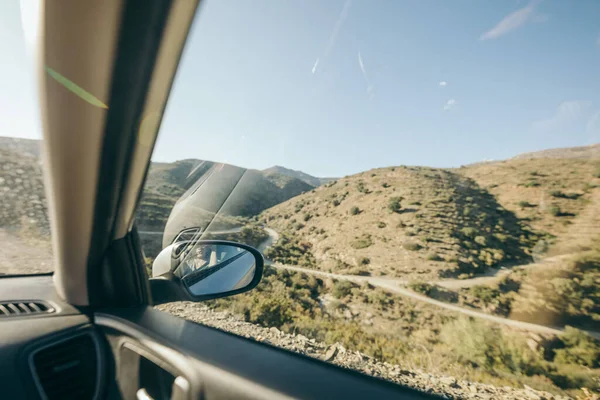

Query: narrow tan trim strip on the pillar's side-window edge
left=113, top=0, right=199, bottom=239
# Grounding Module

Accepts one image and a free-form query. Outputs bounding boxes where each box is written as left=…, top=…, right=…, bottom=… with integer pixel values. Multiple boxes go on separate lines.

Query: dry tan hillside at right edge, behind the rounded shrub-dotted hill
left=454, top=158, right=600, bottom=250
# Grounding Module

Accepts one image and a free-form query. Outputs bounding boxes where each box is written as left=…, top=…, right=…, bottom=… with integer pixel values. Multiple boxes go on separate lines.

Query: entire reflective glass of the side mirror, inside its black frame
left=175, top=243, right=256, bottom=296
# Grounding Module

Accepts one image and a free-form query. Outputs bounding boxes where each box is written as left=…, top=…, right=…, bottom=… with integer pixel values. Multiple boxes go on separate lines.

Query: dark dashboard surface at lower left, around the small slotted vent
left=0, top=275, right=91, bottom=399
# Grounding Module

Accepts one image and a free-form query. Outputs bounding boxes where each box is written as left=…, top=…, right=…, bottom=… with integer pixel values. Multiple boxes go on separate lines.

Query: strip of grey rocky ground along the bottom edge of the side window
left=158, top=302, right=572, bottom=400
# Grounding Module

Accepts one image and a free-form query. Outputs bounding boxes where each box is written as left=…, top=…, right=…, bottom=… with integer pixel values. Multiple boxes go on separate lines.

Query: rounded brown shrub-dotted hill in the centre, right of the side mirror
left=262, top=167, right=539, bottom=279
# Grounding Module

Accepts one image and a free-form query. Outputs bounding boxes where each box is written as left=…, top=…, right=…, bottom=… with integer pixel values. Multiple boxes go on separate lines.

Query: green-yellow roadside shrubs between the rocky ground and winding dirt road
left=210, top=268, right=600, bottom=395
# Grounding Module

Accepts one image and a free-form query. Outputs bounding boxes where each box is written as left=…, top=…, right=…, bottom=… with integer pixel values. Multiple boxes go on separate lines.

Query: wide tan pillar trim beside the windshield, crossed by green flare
left=37, top=0, right=122, bottom=305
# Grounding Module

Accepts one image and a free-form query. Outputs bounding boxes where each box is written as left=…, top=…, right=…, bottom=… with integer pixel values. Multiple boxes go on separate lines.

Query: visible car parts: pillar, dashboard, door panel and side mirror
left=0, top=0, right=433, bottom=400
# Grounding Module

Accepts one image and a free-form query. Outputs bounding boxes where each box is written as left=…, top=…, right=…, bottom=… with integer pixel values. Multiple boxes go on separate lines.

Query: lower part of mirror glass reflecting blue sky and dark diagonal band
left=184, top=251, right=256, bottom=296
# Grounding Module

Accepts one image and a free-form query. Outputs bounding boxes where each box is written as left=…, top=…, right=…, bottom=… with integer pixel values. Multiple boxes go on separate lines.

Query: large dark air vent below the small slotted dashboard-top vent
left=32, top=333, right=99, bottom=400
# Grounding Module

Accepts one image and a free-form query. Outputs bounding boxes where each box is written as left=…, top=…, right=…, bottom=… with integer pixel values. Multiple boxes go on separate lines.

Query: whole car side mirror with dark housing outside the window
left=150, top=240, right=264, bottom=304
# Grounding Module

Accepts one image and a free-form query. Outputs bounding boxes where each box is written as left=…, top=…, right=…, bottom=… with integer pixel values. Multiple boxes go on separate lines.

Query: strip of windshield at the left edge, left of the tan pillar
left=0, top=1, right=53, bottom=275
